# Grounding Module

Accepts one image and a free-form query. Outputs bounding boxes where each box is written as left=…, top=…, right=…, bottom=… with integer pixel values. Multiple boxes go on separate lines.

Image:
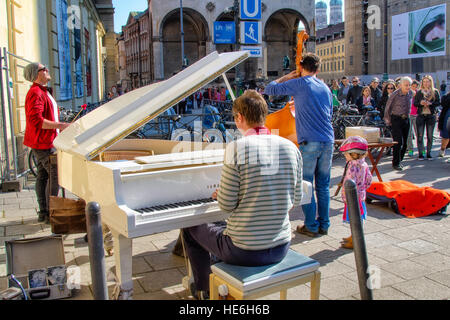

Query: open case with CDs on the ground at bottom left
left=5, top=235, right=72, bottom=300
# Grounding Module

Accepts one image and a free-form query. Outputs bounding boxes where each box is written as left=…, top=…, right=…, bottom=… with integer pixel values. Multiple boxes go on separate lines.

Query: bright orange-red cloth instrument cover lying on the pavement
left=367, top=180, right=450, bottom=218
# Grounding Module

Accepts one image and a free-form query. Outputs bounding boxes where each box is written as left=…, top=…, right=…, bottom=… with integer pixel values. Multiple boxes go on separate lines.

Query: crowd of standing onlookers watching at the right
left=329, top=75, right=449, bottom=166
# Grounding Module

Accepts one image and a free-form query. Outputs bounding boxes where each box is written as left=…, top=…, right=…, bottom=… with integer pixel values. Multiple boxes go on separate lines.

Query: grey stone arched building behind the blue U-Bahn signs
left=149, top=0, right=315, bottom=80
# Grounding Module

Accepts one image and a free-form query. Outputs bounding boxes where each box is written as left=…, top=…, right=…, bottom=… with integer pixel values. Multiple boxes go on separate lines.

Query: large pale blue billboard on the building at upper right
left=392, top=4, right=447, bottom=60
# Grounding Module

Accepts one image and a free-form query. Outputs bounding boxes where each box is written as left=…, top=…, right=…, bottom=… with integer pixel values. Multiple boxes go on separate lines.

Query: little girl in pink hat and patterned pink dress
left=339, top=136, right=372, bottom=249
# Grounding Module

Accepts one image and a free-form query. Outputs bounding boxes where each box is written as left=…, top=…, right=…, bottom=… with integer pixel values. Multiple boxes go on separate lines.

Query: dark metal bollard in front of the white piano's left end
left=86, top=202, right=108, bottom=300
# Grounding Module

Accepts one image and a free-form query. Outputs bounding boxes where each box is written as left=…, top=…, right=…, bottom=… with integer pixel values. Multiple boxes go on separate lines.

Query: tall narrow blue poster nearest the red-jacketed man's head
left=57, top=0, right=72, bottom=100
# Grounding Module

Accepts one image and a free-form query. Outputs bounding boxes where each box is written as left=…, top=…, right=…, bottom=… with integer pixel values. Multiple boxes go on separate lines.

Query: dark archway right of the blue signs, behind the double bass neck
left=264, top=9, right=310, bottom=78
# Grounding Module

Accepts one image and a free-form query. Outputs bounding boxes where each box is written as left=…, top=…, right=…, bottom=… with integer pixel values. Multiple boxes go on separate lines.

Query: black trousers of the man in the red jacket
left=32, top=149, right=59, bottom=212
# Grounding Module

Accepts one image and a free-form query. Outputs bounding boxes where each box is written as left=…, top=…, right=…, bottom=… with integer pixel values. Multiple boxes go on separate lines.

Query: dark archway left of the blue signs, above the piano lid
left=160, top=8, right=209, bottom=79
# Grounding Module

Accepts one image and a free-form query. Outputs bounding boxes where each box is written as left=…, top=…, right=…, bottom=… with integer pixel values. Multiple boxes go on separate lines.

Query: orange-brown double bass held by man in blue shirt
left=265, top=30, right=309, bottom=147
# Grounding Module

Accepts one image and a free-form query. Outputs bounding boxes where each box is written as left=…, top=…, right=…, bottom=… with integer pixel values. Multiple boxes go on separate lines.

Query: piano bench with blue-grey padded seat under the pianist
left=209, top=249, right=320, bottom=300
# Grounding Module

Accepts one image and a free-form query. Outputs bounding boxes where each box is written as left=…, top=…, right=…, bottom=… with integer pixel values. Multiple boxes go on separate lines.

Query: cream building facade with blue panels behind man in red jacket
left=0, top=0, right=111, bottom=134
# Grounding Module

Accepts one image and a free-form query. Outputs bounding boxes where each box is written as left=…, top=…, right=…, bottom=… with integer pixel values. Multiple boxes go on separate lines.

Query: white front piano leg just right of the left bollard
left=111, top=230, right=133, bottom=300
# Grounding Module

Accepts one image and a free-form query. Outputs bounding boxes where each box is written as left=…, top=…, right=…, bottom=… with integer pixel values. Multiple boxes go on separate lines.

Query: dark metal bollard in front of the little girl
left=345, top=179, right=373, bottom=300
